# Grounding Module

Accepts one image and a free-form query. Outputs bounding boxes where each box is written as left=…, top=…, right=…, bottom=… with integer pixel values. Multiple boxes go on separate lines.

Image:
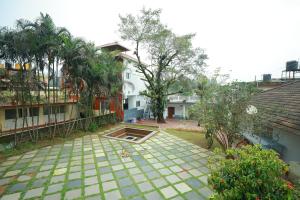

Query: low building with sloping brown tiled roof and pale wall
left=250, top=81, right=300, bottom=162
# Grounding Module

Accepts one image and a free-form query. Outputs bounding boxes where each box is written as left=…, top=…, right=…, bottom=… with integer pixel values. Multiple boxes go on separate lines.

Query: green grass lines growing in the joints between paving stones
left=0, top=126, right=211, bottom=198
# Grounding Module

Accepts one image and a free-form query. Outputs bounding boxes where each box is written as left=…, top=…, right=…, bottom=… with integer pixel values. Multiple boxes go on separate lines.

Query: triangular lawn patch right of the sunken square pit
left=165, top=128, right=221, bottom=150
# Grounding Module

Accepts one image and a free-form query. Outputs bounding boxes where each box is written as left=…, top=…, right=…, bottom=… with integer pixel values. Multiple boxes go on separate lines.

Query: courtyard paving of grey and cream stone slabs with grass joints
left=0, top=126, right=211, bottom=200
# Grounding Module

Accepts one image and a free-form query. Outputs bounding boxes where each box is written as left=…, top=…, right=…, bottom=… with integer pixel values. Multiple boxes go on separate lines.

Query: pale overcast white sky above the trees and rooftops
left=0, top=0, right=300, bottom=81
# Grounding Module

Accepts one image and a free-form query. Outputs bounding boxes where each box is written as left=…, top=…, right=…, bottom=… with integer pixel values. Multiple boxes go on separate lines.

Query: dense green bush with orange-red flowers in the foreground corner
left=208, top=145, right=294, bottom=200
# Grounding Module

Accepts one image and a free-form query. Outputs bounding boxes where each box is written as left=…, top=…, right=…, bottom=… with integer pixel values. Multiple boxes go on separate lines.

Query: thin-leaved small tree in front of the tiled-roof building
left=190, top=74, right=258, bottom=148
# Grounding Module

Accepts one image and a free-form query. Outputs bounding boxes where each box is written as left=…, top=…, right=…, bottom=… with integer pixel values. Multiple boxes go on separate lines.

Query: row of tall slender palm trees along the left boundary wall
left=0, top=13, right=122, bottom=143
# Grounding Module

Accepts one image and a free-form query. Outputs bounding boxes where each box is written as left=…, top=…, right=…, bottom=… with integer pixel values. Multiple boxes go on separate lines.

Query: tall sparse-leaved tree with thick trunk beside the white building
left=119, top=8, right=207, bottom=122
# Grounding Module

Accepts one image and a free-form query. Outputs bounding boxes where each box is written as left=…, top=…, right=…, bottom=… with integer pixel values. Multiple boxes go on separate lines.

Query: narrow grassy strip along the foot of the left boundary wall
left=0, top=124, right=119, bottom=162
